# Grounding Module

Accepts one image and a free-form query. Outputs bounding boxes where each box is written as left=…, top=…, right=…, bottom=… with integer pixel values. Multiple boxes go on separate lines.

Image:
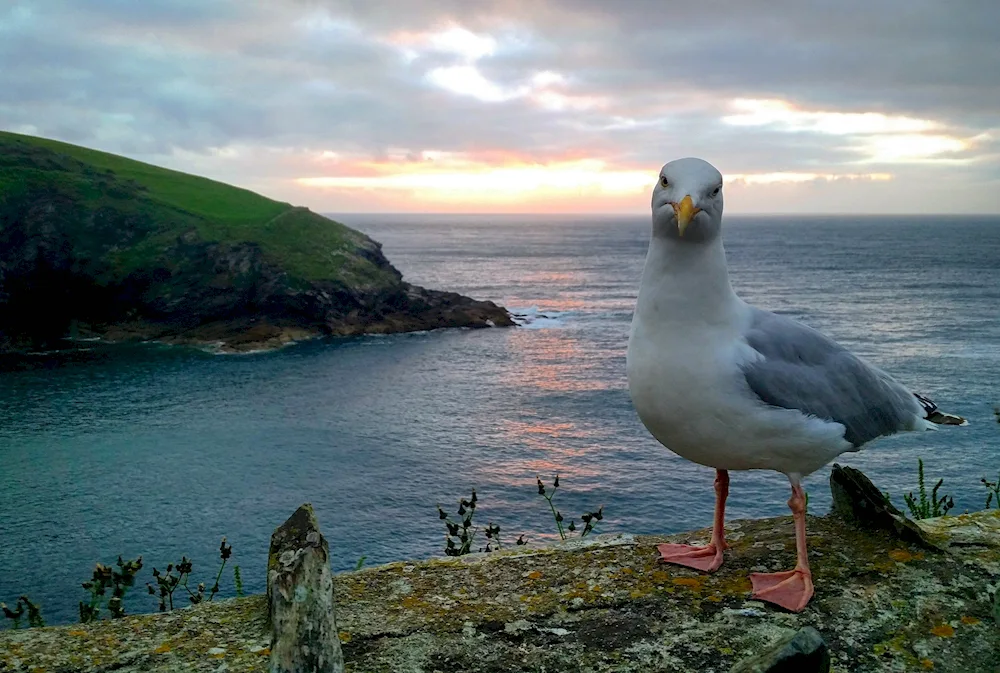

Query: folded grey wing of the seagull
left=743, top=309, right=924, bottom=447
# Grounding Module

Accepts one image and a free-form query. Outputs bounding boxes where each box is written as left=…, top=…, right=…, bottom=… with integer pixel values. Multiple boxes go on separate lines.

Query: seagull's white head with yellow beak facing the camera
left=653, top=158, right=722, bottom=243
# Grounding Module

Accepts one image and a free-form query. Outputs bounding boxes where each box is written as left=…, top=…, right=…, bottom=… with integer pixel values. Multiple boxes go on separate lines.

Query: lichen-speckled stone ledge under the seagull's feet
left=0, top=511, right=1000, bottom=673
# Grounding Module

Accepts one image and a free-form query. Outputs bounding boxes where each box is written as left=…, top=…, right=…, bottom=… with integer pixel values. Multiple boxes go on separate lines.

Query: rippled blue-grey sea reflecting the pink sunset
left=0, top=215, right=1000, bottom=623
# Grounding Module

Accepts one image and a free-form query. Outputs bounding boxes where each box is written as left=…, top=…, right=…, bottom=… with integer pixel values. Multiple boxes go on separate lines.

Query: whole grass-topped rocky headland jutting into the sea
left=0, top=133, right=512, bottom=351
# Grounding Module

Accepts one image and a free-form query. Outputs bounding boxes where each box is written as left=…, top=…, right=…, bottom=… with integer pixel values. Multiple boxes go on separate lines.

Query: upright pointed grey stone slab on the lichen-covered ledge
left=267, top=503, right=344, bottom=673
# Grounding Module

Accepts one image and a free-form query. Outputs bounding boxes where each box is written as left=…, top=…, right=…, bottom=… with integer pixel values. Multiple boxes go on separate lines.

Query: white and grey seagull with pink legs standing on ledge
left=626, top=158, right=966, bottom=612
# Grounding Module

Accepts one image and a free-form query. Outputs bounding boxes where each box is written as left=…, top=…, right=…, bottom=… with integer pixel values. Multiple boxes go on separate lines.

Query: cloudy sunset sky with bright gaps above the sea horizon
left=0, top=0, right=1000, bottom=214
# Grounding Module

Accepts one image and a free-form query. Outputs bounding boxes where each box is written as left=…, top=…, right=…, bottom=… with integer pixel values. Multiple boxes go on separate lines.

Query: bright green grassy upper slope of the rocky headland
left=0, top=131, right=398, bottom=283
